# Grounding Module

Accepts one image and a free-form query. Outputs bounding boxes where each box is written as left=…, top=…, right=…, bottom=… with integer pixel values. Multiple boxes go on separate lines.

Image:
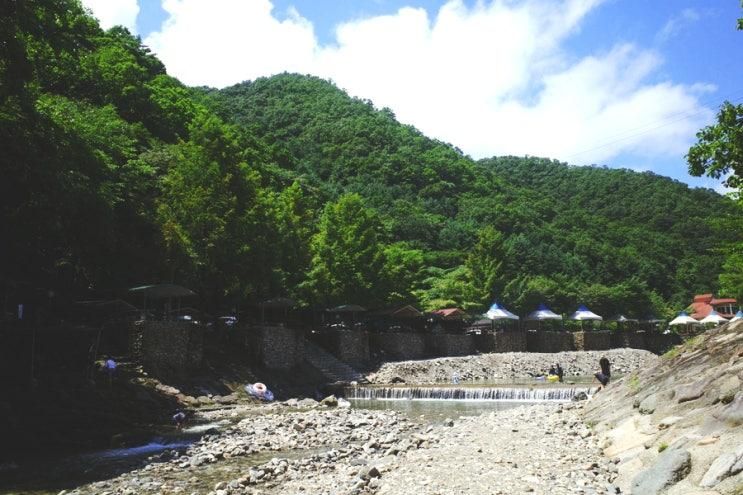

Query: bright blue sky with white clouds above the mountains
left=83, top=0, right=743, bottom=192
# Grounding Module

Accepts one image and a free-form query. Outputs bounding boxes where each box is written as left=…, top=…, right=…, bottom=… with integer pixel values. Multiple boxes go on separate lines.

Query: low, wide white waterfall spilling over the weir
left=345, top=387, right=596, bottom=402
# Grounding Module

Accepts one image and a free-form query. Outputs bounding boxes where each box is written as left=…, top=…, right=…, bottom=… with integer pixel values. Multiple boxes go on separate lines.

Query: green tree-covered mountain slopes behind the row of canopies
left=0, top=0, right=741, bottom=315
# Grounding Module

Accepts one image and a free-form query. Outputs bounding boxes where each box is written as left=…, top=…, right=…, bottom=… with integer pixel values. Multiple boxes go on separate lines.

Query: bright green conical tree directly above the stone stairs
left=305, top=193, right=384, bottom=306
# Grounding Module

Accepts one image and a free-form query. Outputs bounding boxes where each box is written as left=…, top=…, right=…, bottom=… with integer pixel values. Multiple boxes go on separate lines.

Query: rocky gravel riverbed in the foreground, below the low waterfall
left=56, top=399, right=616, bottom=495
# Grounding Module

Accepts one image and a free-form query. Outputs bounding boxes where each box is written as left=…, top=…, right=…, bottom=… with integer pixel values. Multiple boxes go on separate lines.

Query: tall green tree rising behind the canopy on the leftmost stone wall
left=157, top=116, right=265, bottom=310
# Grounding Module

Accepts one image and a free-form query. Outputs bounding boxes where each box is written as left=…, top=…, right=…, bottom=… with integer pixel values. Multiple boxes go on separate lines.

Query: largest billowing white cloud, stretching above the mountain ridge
left=146, top=0, right=712, bottom=167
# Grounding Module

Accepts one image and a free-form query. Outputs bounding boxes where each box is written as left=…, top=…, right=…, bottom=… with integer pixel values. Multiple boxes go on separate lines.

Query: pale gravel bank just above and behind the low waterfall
left=367, top=349, right=659, bottom=384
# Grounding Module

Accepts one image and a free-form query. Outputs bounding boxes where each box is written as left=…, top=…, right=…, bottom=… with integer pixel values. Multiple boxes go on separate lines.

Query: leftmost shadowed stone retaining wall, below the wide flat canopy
left=129, top=321, right=204, bottom=372
